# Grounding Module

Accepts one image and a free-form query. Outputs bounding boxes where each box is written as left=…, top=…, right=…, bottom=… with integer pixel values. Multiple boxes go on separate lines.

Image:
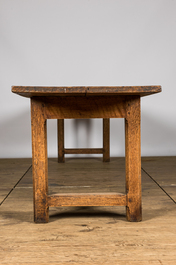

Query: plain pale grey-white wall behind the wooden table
left=0, top=0, right=176, bottom=158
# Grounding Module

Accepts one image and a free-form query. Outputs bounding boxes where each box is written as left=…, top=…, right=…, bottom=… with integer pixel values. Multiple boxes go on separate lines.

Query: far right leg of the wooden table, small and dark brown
left=103, top=119, right=110, bottom=162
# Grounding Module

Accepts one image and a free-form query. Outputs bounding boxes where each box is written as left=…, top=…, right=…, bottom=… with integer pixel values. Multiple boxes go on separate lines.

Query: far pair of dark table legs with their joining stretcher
left=57, top=119, right=110, bottom=163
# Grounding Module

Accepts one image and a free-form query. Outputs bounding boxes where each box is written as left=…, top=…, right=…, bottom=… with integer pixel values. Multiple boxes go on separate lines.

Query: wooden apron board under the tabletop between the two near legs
left=43, top=96, right=126, bottom=119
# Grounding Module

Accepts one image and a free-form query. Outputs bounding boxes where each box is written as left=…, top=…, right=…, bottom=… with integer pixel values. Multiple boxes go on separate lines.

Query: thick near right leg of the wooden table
left=125, top=97, right=142, bottom=222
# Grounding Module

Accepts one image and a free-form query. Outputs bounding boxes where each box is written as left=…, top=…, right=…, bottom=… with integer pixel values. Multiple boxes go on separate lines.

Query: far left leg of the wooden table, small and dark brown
left=57, top=119, right=65, bottom=163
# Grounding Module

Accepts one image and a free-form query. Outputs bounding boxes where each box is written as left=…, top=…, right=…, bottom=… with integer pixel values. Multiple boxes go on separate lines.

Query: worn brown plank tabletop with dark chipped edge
left=12, top=86, right=161, bottom=98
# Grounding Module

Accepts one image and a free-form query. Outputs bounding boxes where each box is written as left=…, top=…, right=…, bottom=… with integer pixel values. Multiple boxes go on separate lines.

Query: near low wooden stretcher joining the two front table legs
left=48, top=193, right=126, bottom=207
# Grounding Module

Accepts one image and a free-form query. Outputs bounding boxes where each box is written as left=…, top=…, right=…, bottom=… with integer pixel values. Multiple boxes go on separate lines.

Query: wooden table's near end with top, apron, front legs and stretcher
left=12, top=86, right=161, bottom=223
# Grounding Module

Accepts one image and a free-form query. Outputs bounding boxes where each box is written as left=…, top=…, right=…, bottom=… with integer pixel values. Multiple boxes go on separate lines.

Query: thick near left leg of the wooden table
left=31, top=98, right=49, bottom=223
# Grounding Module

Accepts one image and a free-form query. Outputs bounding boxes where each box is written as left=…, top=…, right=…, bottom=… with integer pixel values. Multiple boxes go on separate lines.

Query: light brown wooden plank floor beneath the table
left=0, top=157, right=176, bottom=265
